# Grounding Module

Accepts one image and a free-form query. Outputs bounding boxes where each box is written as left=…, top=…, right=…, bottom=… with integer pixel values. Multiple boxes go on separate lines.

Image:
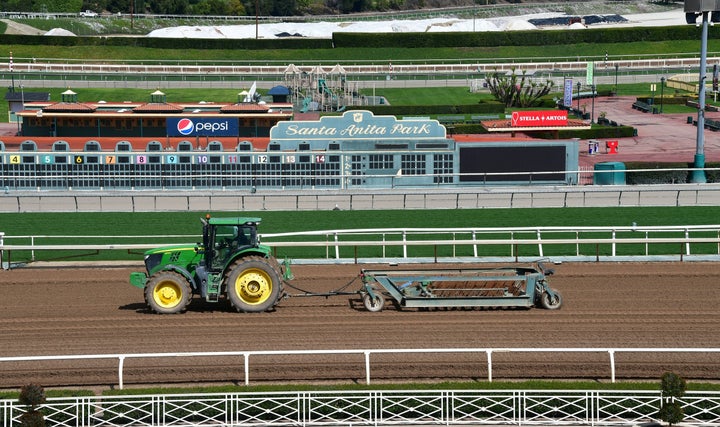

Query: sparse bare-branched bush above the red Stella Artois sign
left=485, top=68, right=555, bottom=108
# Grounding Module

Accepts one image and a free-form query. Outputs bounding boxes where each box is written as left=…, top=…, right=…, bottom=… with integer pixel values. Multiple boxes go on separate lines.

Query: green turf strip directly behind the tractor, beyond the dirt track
left=0, top=207, right=720, bottom=262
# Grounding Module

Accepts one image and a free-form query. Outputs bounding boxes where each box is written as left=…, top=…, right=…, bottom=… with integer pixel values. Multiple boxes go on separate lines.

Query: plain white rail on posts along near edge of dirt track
left=0, top=348, right=720, bottom=392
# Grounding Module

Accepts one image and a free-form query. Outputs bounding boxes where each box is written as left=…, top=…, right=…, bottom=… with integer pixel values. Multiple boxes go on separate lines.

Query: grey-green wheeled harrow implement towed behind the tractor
left=360, top=263, right=562, bottom=311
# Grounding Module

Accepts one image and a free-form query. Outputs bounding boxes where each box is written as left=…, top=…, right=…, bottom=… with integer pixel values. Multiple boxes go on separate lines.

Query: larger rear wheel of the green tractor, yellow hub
left=225, top=256, right=282, bottom=313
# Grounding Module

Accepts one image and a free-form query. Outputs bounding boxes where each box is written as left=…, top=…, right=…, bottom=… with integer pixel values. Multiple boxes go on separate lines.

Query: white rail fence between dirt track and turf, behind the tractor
left=0, top=225, right=720, bottom=268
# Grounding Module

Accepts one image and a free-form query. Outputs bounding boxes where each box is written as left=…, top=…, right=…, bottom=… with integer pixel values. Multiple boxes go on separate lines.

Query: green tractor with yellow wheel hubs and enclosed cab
left=130, top=215, right=291, bottom=314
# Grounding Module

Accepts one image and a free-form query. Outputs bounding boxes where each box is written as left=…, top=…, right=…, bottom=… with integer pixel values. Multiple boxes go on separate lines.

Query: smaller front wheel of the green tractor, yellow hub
left=145, top=271, right=192, bottom=314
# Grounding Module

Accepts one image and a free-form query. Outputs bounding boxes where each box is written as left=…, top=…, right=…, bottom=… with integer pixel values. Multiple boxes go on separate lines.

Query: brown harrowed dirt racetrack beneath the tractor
left=0, top=263, right=720, bottom=388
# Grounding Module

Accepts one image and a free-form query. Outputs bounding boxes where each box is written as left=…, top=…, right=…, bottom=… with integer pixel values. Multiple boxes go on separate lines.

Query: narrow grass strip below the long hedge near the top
left=4, top=39, right=720, bottom=63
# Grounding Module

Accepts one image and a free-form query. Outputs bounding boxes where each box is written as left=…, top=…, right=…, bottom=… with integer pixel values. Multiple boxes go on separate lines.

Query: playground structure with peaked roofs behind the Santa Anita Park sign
left=283, top=64, right=369, bottom=113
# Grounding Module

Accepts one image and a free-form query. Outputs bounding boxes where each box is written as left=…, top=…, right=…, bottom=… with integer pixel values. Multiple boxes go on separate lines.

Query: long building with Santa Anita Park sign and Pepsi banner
left=0, top=91, right=579, bottom=191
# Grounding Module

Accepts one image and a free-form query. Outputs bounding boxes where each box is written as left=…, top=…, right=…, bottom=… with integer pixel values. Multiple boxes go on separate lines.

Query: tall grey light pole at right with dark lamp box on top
left=685, top=0, right=720, bottom=184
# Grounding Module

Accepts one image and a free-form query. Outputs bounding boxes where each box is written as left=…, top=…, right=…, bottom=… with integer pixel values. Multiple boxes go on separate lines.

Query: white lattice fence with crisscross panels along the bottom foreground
left=0, top=390, right=720, bottom=427
